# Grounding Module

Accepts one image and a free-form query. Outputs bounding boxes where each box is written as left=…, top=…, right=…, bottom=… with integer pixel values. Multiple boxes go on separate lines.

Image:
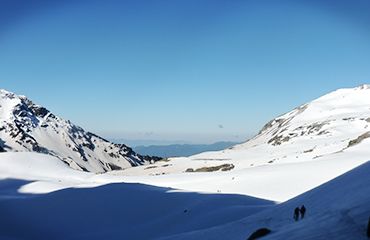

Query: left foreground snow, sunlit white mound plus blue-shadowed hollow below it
left=0, top=153, right=273, bottom=239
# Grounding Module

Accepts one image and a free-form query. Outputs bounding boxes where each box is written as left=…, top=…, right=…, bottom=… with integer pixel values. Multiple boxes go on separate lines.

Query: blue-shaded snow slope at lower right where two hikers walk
left=163, top=159, right=370, bottom=240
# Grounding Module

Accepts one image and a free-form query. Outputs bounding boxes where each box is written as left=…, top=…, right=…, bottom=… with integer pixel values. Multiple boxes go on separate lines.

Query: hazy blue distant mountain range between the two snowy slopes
left=133, top=142, right=238, bottom=158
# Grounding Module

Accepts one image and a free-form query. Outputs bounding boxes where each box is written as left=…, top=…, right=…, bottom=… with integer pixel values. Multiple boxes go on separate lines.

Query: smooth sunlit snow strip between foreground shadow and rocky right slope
left=117, top=155, right=369, bottom=202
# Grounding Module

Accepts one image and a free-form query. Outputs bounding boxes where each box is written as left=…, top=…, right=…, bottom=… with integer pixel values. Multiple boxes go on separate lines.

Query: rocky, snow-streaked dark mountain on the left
left=0, top=90, right=159, bottom=172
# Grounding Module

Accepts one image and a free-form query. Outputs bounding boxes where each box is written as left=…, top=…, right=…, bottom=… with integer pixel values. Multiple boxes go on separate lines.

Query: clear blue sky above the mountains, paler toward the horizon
left=0, top=0, right=370, bottom=142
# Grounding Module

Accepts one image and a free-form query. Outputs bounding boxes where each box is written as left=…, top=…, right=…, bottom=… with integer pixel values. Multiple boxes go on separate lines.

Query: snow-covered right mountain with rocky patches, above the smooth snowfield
left=120, top=85, right=370, bottom=178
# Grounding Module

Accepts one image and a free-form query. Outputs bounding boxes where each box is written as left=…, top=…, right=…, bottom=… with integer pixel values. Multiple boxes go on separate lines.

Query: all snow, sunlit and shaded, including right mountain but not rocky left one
left=0, top=85, right=370, bottom=240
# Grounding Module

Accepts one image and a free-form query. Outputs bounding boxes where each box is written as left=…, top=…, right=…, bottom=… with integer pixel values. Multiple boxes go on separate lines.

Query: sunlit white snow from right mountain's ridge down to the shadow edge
left=113, top=87, right=370, bottom=198
